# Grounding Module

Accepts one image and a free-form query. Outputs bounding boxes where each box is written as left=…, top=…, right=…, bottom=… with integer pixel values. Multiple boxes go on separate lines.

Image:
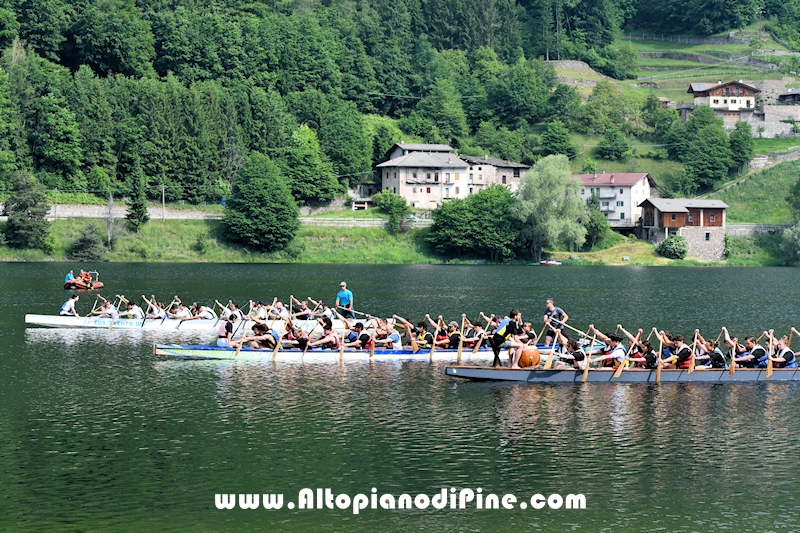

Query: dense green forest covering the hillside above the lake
left=0, top=0, right=780, bottom=202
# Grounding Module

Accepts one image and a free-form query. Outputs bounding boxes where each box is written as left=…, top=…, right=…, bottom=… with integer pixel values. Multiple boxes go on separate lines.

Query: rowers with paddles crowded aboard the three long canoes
left=61, top=290, right=800, bottom=370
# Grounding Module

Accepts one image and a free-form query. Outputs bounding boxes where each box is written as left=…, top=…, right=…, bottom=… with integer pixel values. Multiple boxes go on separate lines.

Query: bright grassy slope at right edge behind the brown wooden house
left=709, top=161, right=800, bottom=224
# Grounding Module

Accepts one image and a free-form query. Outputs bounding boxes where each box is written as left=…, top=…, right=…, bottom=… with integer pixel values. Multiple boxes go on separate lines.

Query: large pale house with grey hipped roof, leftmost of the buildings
left=377, top=152, right=473, bottom=209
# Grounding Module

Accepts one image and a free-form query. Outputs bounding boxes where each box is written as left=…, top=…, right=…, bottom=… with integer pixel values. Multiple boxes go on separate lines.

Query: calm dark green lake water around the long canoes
left=0, top=264, right=800, bottom=532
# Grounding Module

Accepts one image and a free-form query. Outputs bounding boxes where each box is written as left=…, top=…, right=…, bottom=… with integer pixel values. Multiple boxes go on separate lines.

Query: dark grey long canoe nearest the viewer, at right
left=445, top=366, right=800, bottom=383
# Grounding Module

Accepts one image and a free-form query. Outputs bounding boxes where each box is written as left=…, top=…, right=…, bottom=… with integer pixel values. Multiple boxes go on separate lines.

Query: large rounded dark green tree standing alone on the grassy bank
left=222, top=152, right=300, bottom=252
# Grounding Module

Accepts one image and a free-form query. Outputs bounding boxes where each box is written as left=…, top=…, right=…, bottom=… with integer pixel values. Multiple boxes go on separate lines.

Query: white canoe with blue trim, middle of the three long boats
left=153, top=344, right=508, bottom=362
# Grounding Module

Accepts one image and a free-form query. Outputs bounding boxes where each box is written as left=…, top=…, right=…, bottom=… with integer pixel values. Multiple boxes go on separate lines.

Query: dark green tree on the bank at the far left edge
left=3, top=173, right=50, bottom=249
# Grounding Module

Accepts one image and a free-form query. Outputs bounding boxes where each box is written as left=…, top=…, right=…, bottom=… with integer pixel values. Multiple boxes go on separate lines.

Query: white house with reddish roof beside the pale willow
left=575, top=172, right=656, bottom=229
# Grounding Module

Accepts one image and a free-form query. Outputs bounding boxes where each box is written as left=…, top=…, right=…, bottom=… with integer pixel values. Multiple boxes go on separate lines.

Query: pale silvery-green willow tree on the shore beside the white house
left=511, top=155, right=586, bottom=261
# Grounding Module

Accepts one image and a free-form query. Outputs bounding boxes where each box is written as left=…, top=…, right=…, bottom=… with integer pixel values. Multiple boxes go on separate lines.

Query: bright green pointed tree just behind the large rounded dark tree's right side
left=285, top=124, right=342, bottom=204
